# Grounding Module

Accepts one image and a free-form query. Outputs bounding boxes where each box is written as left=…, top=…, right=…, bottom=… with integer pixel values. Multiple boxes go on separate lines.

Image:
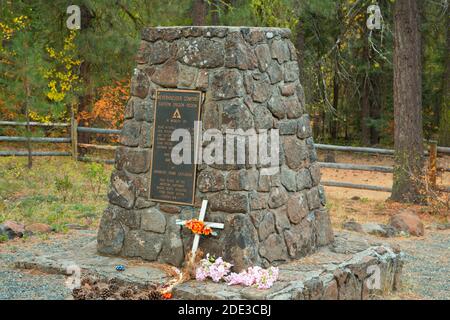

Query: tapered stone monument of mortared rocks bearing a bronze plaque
left=97, top=27, right=333, bottom=271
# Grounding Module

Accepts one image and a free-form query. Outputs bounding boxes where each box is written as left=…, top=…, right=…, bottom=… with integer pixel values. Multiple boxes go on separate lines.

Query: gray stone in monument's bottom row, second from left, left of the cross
left=122, top=230, right=164, bottom=261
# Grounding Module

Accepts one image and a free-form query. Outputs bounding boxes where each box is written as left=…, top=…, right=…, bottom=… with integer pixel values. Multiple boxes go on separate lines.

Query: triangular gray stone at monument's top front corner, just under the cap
left=225, top=32, right=257, bottom=70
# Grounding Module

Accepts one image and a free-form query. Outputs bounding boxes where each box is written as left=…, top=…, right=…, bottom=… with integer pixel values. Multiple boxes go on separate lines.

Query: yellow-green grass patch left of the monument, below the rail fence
left=0, top=157, right=112, bottom=232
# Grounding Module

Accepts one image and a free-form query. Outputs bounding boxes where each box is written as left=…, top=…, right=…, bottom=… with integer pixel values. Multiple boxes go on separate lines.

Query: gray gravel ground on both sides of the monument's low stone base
left=0, top=230, right=450, bottom=300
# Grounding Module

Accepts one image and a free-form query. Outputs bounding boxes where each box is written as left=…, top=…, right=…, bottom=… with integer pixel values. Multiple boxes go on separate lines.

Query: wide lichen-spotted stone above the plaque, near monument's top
left=177, top=38, right=225, bottom=68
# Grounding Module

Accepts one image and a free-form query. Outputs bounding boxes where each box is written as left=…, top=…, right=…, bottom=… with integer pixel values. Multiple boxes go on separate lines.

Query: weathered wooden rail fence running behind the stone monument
left=0, top=119, right=450, bottom=192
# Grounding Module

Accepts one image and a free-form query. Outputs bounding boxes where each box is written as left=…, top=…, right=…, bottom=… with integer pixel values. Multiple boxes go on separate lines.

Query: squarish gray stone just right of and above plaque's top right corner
left=211, top=69, right=244, bottom=100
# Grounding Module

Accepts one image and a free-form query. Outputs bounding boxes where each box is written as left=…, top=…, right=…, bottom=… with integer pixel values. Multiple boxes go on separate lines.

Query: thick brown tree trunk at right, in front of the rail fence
left=391, top=0, right=423, bottom=202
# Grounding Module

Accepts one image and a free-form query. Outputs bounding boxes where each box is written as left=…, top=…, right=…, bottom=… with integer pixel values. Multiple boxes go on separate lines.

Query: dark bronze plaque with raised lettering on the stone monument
left=150, top=90, right=201, bottom=205
